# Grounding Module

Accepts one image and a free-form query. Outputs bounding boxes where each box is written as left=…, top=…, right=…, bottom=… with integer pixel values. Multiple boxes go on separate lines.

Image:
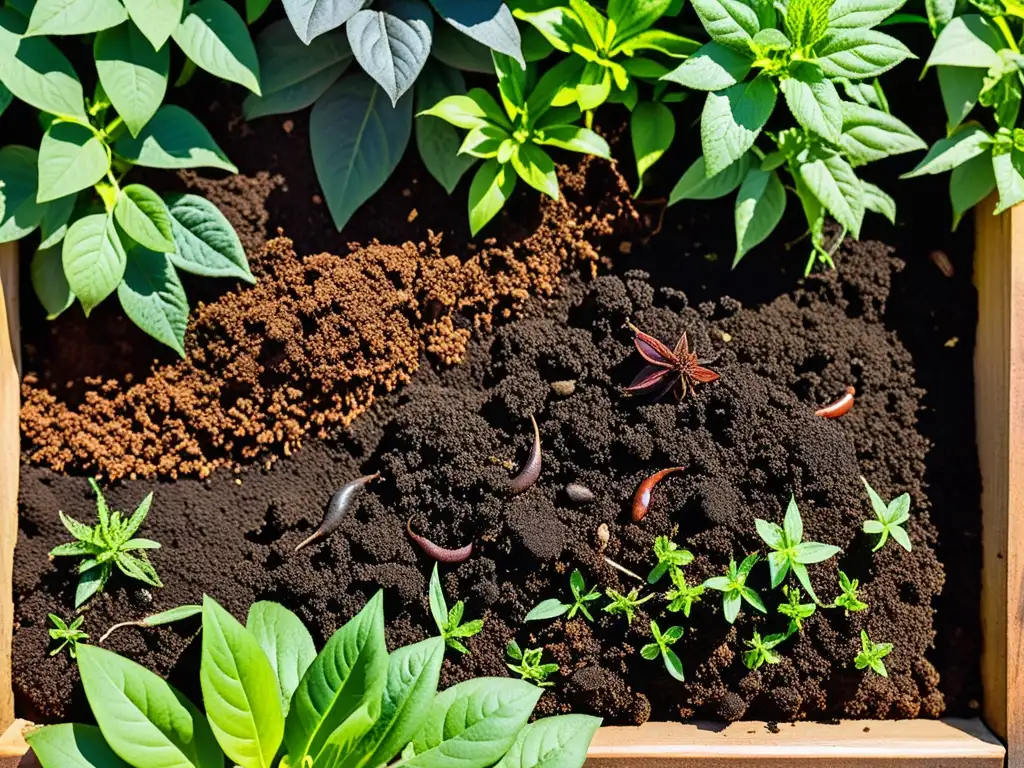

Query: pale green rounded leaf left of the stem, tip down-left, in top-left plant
left=36, top=121, right=111, bottom=203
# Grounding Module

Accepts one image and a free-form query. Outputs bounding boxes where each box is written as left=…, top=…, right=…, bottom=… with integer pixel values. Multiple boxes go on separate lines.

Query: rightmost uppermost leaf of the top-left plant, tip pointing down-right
left=171, top=0, right=260, bottom=95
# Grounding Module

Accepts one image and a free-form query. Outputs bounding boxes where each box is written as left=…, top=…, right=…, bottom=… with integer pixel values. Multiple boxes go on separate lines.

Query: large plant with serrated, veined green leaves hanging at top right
left=664, top=0, right=925, bottom=271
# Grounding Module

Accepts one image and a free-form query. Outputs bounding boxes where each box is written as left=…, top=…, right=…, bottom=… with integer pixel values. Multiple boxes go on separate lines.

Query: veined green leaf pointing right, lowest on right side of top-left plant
left=167, top=195, right=256, bottom=283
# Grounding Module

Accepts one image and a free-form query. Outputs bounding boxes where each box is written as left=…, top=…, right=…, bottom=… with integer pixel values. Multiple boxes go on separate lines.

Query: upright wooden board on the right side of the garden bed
left=974, top=193, right=1024, bottom=768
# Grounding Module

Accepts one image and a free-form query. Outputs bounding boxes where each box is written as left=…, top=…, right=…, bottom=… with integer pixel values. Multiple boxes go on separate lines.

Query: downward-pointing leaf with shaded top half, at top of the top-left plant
left=92, top=22, right=171, bottom=136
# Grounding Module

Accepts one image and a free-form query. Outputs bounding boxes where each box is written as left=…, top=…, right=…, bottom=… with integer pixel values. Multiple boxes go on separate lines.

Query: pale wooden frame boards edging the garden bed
left=0, top=201, right=1024, bottom=768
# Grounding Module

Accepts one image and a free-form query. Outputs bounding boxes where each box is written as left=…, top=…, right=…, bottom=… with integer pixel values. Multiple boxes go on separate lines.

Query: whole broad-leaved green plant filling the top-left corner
left=0, top=0, right=259, bottom=356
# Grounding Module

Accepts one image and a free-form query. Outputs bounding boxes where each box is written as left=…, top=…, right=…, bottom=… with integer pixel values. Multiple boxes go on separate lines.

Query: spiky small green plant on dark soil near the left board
left=50, top=477, right=164, bottom=608
